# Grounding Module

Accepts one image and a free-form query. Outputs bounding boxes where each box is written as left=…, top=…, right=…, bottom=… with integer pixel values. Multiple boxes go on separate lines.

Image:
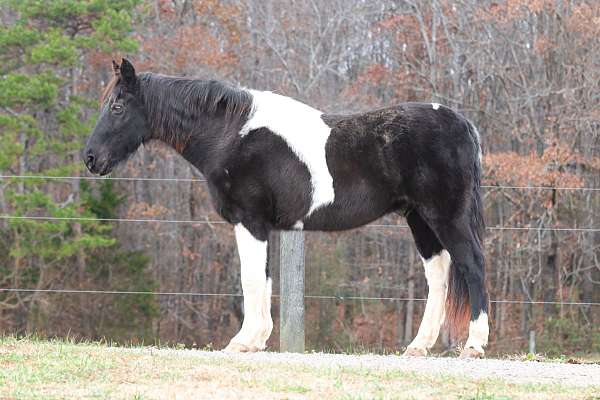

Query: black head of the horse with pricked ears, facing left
left=83, top=59, right=150, bottom=175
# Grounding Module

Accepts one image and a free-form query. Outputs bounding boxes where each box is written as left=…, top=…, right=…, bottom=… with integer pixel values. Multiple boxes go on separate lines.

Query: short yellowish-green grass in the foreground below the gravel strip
left=0, top=337, right=600, bottom=400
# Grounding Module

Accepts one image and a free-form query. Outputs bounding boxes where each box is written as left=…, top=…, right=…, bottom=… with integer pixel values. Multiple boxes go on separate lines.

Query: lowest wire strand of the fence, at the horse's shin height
left=0, top=288, right=600, bottom=306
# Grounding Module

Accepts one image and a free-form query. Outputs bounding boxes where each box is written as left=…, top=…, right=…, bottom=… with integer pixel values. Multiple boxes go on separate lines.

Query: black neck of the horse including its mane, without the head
left=140, top=74, right=252, bottom=174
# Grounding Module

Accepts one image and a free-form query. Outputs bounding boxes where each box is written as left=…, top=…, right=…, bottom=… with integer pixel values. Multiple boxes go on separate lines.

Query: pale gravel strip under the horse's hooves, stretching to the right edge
left=145, top=349, right=600, bottom=390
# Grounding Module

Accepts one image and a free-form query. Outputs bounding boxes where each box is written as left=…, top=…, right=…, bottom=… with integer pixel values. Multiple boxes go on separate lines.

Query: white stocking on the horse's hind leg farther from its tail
left=408, top=250, right=451, bottom=354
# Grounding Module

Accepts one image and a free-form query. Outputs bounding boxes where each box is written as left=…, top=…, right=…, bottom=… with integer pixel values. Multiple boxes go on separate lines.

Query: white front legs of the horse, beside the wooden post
left=225, top=224, right=273, bottom=352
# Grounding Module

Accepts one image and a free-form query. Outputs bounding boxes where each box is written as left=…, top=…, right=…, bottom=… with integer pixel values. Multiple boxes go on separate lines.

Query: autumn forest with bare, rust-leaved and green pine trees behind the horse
left=0, top=0, right=600, bottom=354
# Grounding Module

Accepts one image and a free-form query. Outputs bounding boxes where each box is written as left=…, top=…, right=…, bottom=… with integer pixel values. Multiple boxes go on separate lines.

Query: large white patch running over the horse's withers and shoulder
left=240, top=90, right=335, bottom=216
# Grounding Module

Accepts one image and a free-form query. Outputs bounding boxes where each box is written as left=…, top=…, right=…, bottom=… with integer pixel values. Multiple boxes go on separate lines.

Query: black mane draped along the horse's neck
left=138, top=73, right=252, bottom=146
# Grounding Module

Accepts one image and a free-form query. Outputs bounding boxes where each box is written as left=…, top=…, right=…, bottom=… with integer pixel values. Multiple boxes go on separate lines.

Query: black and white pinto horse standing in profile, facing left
left=84, top=59, right=489, bottom=357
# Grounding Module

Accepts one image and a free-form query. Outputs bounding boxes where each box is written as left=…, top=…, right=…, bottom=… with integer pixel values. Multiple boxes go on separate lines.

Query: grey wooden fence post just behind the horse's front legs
left=279, top=231, right=304, bottom=353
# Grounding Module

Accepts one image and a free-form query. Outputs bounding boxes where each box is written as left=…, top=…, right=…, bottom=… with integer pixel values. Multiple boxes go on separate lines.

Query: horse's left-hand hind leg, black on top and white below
left=404, top=211, right=450, bottom=356
